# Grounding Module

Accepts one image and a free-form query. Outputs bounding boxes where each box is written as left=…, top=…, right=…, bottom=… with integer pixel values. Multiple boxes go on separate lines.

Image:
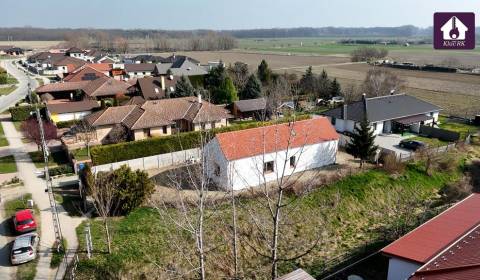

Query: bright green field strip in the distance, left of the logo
left=238, top=38, right=480, bottom=55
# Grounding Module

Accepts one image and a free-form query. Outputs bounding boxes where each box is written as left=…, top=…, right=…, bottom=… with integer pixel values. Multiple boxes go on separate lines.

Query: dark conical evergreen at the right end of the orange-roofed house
left=346, top=117, right=378, bottom=167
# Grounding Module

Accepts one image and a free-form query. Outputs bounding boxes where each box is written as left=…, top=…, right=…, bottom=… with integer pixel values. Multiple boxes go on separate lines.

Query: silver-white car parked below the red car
left=10, top=232, right=40, bottom=265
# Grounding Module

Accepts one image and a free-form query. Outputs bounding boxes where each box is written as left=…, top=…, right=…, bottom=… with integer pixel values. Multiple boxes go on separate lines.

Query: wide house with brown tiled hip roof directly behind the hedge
left=86, top=97, right=231, bottom=142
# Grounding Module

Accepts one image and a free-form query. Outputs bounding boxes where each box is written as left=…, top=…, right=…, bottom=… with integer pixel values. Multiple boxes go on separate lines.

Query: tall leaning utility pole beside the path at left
left=27, top=72, right=66, bottom=252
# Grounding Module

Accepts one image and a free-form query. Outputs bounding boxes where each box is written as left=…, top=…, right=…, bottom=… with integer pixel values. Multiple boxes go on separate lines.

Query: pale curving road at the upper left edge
left=0, top=60, right=38, bottom=112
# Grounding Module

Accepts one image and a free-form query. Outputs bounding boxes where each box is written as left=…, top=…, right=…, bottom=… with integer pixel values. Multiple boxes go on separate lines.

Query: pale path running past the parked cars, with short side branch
left=2, top=121, right=82, bottom=280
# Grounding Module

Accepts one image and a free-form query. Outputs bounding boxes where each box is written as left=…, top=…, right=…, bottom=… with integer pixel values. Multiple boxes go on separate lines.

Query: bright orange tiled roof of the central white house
left=216, top=117, right=339, bottom=160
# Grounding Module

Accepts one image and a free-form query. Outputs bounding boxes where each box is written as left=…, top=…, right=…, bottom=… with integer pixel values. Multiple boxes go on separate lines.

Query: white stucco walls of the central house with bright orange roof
left=206, top=139, right=338, bottom=190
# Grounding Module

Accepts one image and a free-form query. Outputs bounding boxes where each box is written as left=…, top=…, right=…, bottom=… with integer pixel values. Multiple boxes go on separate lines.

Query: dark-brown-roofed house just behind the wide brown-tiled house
left=130, top=75, right=179, bottom=100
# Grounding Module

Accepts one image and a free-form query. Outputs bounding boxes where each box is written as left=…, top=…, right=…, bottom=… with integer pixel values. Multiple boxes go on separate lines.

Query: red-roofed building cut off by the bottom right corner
left=382, top=194, right=480, bottom=280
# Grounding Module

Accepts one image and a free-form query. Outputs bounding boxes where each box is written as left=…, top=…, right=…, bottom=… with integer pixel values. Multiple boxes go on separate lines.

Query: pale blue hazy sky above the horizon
left=0, top=0, right=480, bottom=30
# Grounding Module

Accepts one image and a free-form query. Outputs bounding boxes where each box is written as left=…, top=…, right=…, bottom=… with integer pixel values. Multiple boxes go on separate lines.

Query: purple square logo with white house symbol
left=433, top=13, right=475, bottom=50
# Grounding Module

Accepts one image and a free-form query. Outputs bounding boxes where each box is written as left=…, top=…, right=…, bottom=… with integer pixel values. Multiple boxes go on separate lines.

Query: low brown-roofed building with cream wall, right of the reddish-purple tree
left=47, top=99, right=100, bottom=123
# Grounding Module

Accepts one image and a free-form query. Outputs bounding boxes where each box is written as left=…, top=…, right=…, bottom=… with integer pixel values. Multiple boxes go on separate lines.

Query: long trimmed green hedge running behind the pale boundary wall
left=90, top=115, right=310, bottom=165
